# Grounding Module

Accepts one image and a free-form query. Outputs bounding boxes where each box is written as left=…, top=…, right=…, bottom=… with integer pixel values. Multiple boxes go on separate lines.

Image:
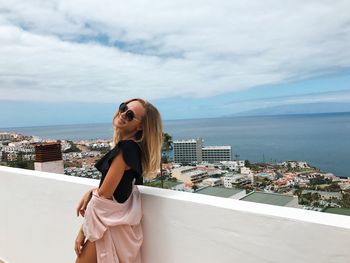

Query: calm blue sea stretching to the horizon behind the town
left=0, top=113, right=350, bottom=177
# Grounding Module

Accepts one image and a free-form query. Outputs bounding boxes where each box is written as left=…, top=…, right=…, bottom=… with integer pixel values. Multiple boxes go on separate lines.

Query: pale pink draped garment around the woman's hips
left=83, top=185, right=143, bottom=263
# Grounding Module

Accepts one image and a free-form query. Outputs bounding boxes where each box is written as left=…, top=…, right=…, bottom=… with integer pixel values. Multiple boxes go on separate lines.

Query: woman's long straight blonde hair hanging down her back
left=112, top=98, right=163, bottom=178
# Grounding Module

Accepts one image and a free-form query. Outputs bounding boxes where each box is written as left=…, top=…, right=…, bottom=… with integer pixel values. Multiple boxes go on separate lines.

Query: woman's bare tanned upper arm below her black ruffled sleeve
left=98, top=154, right=129, bottom=199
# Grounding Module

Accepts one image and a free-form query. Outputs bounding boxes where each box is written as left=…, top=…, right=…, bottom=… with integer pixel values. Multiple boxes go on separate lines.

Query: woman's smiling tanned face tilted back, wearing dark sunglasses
left=114, top=100, right=145, bottom=134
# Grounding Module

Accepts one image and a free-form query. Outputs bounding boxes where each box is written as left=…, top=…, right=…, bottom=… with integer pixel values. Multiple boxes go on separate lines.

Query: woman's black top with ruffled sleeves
left=95, top=140, right=143, bottom=203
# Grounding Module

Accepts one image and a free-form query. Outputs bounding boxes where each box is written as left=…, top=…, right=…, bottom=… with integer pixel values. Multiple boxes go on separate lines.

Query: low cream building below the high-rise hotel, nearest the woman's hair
left=171, top=166, right=208, bottom=184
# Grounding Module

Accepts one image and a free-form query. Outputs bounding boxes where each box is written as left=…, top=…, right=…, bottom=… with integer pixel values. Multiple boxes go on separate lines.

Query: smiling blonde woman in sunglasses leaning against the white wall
left=75, top=99, right=163, bottom=263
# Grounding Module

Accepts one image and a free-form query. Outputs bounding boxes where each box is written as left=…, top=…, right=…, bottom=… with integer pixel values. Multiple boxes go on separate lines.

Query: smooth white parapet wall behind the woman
left=0, top=167, right=350, bottom=263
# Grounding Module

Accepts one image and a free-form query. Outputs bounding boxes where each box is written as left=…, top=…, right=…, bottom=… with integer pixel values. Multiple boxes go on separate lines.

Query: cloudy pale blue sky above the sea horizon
left=0, top=0, right=350, bottom=127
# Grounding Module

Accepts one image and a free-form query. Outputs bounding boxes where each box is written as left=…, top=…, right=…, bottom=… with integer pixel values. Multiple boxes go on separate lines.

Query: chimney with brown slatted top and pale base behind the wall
left=34, top=142, right=64, bottom=174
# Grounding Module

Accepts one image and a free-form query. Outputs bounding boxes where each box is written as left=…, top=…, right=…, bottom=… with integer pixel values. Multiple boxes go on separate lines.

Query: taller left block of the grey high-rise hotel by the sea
left=173, top=138, right=203, bottom=163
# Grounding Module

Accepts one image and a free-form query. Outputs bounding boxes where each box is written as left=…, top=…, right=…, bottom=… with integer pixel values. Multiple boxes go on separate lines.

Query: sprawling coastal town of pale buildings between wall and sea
left=0, top=132, right=350, bottom=215
